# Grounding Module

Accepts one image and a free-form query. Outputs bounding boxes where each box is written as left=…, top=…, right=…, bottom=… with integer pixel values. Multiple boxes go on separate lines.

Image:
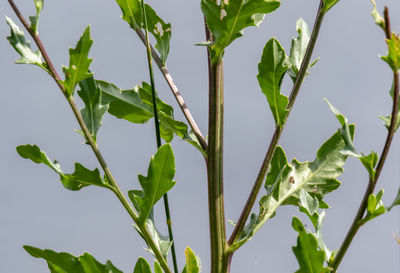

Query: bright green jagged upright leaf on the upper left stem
left=61, top=26, right=93, bottom=97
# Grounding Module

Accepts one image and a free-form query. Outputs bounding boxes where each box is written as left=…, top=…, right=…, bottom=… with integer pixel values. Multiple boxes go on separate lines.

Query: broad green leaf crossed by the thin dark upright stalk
left=97, top=81, right=205, bottom=154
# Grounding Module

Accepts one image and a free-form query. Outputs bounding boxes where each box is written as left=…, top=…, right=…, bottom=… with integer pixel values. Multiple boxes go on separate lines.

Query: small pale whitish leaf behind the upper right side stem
left=288, top=18, right=310, bottom=82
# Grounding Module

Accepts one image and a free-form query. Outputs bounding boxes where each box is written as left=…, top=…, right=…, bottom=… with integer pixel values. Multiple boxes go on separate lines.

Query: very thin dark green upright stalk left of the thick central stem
left=141, top=0, right=178, bottom=273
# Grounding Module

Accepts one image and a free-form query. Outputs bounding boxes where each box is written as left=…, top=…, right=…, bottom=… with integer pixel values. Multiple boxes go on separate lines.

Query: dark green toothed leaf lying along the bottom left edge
left=24, top=246, right=122, bottom=273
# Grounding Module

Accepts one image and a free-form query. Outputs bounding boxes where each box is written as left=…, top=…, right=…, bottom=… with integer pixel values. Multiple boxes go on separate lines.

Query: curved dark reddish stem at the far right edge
left=332, top=7, right=399, bottom=273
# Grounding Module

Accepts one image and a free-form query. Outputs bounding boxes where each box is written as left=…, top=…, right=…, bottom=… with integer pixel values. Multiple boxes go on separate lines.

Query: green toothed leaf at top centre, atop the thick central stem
left=201, top=0, right=280, bottom=63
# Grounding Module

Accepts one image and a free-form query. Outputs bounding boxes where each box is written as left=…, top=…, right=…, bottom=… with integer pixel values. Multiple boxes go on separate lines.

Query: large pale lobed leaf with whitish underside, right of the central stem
left=233, top=125, right=354, bottom=248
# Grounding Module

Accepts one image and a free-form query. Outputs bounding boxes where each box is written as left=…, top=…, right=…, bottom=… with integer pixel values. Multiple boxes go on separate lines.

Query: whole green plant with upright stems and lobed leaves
left=3, top=0, right=400, bottom=272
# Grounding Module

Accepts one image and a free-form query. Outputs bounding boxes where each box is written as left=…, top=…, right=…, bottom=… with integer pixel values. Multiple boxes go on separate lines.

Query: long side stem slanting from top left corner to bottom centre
left=8, top=0, right=171, bottom=273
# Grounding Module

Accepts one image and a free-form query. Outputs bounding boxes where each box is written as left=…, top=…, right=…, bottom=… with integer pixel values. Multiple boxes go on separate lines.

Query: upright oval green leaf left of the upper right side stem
left=257, top=38, right=288, bottom=128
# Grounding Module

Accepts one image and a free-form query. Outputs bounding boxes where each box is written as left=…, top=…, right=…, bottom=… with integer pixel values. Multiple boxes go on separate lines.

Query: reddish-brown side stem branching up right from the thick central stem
left=228, top=0, right=325, bottom=246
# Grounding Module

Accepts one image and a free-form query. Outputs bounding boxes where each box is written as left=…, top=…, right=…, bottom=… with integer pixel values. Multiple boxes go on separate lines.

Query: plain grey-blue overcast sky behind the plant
left=0, top=0, right=400, bottom=273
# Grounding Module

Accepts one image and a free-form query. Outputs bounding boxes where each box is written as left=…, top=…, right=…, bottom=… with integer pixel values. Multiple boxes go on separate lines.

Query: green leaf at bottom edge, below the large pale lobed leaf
left=292, top=217, right=330, bottom=273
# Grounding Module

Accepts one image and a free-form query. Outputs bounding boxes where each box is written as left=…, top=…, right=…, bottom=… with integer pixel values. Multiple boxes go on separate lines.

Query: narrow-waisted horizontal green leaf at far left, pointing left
left=17, top=145, right=112, bottom=191
